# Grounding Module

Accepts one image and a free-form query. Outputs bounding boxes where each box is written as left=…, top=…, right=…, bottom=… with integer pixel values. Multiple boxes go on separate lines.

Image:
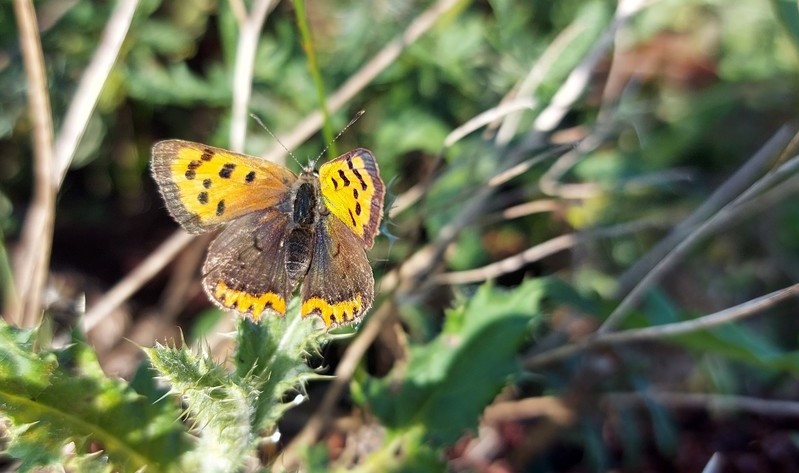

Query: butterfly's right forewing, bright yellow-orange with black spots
left=319, top=148, right=385, bottom=248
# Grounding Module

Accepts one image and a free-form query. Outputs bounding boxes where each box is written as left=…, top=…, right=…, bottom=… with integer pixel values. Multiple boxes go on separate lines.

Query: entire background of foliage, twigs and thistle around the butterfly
left=0, top=0, right=799, bottom=472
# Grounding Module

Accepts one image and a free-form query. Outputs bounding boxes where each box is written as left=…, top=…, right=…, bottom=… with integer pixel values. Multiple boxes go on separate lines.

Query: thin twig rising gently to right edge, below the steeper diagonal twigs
left=524, top=284, right=799, bottom=370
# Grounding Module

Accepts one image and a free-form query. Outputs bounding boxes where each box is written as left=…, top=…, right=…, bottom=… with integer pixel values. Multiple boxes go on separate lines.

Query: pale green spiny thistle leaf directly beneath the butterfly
left=145, top=304, right=326, bottom=472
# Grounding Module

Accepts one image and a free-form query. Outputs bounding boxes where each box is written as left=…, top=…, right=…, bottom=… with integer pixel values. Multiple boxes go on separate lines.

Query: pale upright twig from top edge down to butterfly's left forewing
left=230, top=0, right=276, bottom=151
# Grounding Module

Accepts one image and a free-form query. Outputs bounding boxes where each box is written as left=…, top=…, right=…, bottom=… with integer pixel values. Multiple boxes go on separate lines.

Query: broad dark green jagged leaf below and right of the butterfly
left=363, top=280, right=548, bottom=445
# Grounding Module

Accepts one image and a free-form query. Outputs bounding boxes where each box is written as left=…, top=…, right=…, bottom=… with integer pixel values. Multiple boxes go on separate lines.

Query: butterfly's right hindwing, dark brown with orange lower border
left=300, top=215, right=375, bottom=327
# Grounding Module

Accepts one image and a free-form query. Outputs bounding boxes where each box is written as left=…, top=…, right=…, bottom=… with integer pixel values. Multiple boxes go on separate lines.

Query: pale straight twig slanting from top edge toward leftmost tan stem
left=53, top=0, right=139, bottom=187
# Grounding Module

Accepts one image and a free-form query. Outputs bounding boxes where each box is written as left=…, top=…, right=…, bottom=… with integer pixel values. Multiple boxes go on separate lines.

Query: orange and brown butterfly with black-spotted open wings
left=152, top=140, right=385, bottom=328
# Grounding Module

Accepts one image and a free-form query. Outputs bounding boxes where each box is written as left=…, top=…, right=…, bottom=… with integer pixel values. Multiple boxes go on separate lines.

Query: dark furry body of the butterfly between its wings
left=284, top=170, right=324, bottom=283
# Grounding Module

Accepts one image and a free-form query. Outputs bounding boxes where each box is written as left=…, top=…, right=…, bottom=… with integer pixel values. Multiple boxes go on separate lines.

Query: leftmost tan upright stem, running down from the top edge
left=8, top=0, right=56, bottom=326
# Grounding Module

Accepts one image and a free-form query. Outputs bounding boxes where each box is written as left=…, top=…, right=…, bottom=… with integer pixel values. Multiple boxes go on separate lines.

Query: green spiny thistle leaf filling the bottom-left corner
left=0, top=322, right=188, bottom=471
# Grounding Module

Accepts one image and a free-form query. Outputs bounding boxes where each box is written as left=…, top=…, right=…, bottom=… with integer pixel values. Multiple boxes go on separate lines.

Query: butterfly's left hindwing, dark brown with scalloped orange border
left=203, top=209, right=293, bottom=321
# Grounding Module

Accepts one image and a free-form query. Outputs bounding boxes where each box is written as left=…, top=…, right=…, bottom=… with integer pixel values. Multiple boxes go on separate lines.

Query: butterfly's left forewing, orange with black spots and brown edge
left=152, top=140, right=296, bottom=233
